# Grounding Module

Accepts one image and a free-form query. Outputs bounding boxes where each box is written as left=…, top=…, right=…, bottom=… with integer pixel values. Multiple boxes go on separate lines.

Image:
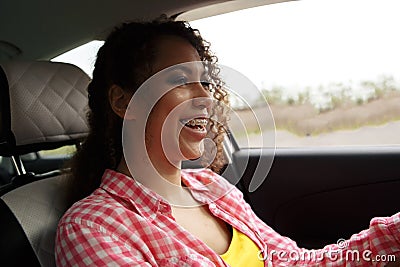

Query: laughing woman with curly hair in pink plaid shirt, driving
left=56, top=21, right=400, bottom=266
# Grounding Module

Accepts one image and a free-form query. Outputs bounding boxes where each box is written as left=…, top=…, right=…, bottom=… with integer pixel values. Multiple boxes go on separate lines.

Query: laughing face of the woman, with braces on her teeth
left=145, top=36, right=212, bottom=164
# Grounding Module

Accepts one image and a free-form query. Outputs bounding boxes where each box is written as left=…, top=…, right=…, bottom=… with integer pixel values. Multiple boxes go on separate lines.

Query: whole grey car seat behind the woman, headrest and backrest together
left=0, top=61, right=90, bottom=266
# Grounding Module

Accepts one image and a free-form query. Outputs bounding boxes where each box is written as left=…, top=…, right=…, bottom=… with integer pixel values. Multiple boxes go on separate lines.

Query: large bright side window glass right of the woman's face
left=191, top=0, right=400, bottom=147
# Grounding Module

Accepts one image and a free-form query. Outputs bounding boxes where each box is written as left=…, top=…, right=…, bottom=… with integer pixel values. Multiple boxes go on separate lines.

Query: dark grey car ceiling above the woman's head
left=0, top=0, right=292, bottom=61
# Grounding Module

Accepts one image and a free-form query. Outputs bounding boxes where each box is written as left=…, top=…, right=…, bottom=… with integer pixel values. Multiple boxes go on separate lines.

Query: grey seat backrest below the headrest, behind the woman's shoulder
left=1, top=174, right=69, bottom=266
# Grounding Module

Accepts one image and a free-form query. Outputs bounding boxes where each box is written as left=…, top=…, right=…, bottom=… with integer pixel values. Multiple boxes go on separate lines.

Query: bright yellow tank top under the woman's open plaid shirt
left=221, top=227, right=264, bottom=267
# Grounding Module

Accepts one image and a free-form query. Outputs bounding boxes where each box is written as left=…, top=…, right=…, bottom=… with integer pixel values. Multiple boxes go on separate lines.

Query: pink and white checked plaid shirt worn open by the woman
left=55, top=170, right=400, bottom=266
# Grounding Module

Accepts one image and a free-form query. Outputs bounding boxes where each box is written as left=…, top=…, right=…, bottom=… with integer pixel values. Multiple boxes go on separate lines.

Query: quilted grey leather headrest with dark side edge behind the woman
left=0, top=61, right=90, bottom=156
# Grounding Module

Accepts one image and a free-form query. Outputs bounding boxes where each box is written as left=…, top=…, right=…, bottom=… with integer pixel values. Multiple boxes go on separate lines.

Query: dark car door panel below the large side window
left=229, top=147, right=400, bottom=248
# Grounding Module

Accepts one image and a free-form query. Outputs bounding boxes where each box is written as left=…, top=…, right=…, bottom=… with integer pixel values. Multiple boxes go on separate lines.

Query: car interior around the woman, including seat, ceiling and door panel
left=0, top=0, right=400, bottom=266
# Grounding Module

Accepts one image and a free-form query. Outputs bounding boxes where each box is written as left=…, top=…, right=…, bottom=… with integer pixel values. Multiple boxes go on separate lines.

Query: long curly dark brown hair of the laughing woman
left=71, top=19, right=228, bottom=202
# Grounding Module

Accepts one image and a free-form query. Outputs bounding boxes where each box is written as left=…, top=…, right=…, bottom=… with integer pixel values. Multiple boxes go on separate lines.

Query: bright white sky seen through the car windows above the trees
left=54, top=0, right=400, bottom=103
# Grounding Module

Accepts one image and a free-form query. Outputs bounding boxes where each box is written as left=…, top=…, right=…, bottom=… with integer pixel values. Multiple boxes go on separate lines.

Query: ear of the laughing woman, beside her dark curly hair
left=108, top=84, right=134, bottom=120
